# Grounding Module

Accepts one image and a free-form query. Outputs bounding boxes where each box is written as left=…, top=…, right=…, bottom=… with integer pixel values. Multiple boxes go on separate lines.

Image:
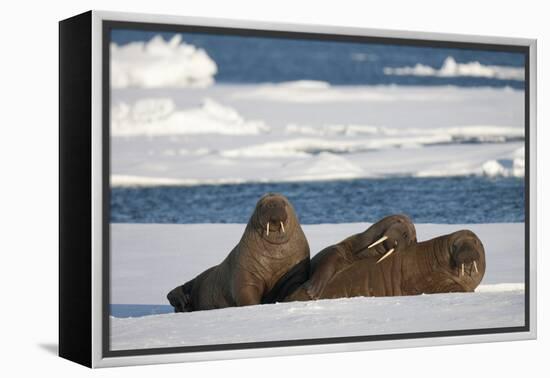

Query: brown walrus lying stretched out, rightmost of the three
left=286, top=230, right=486, bottom=301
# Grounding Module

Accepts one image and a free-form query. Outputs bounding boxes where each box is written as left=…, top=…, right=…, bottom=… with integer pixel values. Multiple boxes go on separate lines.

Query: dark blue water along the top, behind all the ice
left=111, top=29, right=524, bottom=88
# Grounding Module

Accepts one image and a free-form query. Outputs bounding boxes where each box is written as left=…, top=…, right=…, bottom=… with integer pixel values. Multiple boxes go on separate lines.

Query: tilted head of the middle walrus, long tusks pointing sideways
left=353, top=214, right=416, bottom=263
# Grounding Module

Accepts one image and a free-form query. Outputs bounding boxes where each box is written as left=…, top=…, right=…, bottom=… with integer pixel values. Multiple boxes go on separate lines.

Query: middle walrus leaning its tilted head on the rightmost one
left=288, top=214, right=416, bottom=299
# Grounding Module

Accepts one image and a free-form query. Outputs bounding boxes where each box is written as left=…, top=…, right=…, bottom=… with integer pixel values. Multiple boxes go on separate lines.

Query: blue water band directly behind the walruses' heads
left=111, top=177, right=525, bottom=224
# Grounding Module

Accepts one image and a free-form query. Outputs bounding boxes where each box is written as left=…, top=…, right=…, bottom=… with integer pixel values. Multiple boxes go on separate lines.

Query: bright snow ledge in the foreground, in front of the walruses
left=111, top=290, right=525, bottom=350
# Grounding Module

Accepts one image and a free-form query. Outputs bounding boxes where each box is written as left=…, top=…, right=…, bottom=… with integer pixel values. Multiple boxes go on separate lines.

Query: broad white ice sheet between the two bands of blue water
left=111, top=81, right=525, bottom=186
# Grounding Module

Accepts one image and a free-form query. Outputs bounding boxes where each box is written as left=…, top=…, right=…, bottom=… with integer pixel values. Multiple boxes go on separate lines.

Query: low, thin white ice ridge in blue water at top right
left=384, top=56, right=525, bottom=81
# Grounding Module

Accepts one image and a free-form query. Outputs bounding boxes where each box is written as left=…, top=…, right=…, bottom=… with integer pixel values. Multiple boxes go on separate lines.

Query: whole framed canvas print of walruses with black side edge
left=59, top=11, right=536, bottom=367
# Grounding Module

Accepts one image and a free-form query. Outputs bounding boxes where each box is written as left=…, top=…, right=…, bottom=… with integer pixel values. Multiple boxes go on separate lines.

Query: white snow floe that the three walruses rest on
left=110, top=223, right=524, bottom=350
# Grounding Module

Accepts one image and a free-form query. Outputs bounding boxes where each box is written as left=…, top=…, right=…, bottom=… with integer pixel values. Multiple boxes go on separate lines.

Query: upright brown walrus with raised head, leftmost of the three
left=167, top=193, right=309, bottom=312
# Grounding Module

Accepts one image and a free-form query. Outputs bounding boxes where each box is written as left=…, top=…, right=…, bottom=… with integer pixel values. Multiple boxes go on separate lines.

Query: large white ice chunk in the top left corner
left=111, top=34, right=218, bottom=88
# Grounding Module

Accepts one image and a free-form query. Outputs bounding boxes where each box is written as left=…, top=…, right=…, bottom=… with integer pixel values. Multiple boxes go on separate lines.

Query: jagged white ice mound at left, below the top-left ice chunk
left=111, top=98, right=269, bottom=137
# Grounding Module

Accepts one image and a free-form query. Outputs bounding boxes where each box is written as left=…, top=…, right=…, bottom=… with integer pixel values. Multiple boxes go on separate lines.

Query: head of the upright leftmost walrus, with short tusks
left=250, top=193, right=298, bottom=244
